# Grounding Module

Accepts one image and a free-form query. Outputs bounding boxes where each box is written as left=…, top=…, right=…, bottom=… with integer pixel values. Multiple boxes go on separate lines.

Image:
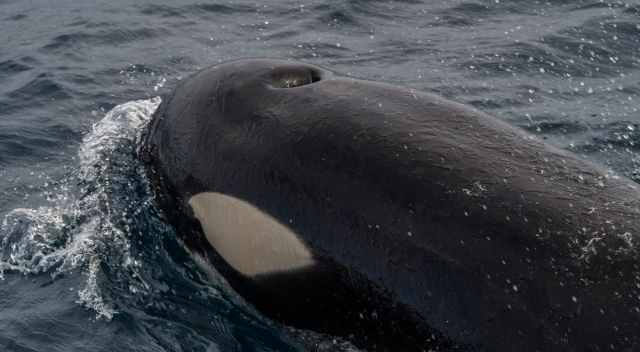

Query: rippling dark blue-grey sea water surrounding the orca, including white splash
left=0, top=0, right=640, bottom=352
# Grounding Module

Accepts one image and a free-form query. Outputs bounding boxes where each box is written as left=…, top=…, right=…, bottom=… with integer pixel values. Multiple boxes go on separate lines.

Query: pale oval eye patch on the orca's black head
left=189, top=192, right=314, bottom=276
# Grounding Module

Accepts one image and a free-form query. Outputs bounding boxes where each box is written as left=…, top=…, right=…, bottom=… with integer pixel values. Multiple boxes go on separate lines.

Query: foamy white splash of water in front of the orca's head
left=0, top=98, right=160, bottom=320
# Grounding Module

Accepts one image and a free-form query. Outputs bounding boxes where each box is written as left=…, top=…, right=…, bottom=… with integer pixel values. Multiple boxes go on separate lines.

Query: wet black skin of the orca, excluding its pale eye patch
left=142, top=59, right=640, bottom=351
